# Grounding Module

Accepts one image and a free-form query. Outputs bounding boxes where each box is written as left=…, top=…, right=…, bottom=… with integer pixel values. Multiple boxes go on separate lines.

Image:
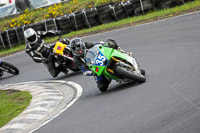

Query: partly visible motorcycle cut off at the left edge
left=0, top=60, right=19, bottom=77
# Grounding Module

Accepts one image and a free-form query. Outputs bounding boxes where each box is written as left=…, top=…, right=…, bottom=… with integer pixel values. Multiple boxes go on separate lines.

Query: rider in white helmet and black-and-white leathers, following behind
left=24, top=28, right=69, bottom=77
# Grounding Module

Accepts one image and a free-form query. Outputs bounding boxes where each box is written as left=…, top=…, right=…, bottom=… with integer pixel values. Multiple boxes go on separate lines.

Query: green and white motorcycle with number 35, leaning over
left=85, top=45, right=146, bottom=92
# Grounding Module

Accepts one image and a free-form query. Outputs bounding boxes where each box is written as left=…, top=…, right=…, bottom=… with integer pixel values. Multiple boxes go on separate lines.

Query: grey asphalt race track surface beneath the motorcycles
left=0, top=12, right=200, bottom=133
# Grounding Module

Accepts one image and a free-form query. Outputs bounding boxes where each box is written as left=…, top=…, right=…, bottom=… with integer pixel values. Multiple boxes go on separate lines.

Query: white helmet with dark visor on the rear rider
left=24, top=28, right=38, bottom=44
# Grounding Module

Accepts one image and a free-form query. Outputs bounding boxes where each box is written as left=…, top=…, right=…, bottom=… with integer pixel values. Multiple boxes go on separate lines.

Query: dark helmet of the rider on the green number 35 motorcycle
left=70, top=38, right=85, bottom=57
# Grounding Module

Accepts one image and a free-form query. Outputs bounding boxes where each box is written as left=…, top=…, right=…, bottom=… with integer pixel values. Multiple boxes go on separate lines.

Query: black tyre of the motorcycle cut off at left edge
left=0, top=61, right=19, bottom=75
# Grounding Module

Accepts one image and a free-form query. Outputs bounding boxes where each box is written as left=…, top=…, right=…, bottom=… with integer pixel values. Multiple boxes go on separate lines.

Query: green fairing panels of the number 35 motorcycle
left=88, top=45, right=127, bottom=80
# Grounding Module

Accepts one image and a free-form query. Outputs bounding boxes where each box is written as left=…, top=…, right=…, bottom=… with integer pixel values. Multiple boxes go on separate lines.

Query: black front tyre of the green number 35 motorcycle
left=115, top=66, right=146, bottom=83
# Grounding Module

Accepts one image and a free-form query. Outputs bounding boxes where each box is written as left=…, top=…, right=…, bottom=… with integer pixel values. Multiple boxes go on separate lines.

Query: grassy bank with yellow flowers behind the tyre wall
left=0, top=0, right=120, bottom=31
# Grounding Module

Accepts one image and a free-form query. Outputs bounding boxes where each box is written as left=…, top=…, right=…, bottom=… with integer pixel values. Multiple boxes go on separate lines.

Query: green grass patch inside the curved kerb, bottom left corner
left=0, top=90, right=32, bottom=127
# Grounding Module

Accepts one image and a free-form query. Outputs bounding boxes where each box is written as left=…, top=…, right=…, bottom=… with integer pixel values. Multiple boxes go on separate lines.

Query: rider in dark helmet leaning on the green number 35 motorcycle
left=70, top=38, right=133, bottom=90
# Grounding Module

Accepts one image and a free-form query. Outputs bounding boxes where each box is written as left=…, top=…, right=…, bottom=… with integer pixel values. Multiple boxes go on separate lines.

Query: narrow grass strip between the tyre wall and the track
left=0, top=0, right=200, bottom=56
